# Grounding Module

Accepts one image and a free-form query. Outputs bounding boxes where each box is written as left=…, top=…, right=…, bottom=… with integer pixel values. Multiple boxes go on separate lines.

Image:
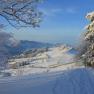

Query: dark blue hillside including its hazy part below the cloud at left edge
left=0, top=40, right=53, bottom=69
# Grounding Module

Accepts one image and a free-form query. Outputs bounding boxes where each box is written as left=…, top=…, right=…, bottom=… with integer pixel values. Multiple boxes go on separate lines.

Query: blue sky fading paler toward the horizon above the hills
left=6, top=0, right=94, bottom=45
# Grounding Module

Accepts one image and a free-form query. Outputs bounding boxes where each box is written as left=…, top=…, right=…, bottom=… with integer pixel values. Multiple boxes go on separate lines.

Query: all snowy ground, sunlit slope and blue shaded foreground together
left=0, top=47, right=91, bottom=94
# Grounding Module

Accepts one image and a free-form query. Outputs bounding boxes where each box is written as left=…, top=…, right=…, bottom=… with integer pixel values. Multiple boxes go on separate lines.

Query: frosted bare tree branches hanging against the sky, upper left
left=0, top=0, right=42, bottom=27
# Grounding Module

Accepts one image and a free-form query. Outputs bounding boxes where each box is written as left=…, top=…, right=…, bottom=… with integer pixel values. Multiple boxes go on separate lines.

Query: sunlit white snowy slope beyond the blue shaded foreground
left=4, top=45, right=76, bottom=76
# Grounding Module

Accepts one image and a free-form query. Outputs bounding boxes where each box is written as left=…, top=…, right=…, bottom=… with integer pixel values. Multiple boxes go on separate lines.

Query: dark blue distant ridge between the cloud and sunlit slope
left=5, top=40, right=53, bottom=55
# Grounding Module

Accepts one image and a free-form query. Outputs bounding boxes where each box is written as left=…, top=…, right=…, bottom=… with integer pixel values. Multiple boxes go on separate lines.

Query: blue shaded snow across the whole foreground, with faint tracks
left=0, top=68, right=94, bottom=94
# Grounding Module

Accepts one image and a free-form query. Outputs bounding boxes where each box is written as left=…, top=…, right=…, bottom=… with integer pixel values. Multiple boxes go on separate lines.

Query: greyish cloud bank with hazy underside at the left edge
left=0, top=31, right=18, bottom=67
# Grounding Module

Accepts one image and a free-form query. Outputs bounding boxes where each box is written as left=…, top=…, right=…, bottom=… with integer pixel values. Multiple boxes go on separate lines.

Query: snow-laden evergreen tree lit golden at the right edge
left=82, top=12, right=94, bottom=67
